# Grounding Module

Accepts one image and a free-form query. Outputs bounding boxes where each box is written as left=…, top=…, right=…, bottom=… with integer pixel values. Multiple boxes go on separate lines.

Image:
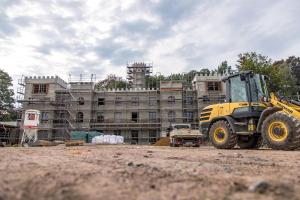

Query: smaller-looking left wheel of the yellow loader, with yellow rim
left=209, top=120, right=237, bottom=149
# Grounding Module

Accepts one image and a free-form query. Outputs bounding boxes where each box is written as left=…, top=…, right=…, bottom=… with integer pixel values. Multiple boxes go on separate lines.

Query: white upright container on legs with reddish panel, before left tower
left=21, top=110, right=41, bottom=144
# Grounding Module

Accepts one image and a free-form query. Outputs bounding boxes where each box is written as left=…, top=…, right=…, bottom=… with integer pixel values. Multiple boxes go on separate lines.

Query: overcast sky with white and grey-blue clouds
left=0, top=0, right=300, bottom=84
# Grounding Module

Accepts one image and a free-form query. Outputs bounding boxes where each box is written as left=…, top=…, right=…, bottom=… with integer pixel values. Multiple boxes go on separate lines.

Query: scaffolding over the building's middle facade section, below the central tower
left=91, top=89, right=161, bottom=144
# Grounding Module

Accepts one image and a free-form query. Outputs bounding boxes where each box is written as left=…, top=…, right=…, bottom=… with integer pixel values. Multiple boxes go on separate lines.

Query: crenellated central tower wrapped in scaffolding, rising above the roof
left=127, top=62, right=153, bottom=88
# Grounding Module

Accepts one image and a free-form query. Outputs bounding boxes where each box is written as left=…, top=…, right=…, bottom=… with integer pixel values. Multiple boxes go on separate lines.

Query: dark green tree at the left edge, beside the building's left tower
left=0, top=69, right=16, bottom=121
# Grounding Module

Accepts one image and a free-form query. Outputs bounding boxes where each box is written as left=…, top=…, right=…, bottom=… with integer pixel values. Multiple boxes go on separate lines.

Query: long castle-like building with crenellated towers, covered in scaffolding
left=19, top=63, right=225, bottom=144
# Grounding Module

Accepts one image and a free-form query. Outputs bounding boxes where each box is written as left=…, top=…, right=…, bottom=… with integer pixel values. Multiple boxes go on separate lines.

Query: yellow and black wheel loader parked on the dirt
left=200, top=71, right=300, bottom=150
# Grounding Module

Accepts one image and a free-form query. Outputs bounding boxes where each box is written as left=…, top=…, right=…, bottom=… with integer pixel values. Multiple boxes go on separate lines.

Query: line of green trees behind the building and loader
left=96, top=52, right=300, bottom=95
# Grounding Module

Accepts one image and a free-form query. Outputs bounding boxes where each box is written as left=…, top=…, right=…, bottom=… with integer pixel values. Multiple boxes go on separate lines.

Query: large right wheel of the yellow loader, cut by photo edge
left=262, top=112, right=300, bottom=150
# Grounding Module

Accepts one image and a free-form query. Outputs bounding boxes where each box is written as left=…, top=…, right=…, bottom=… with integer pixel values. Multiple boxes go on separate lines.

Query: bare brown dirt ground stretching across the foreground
left=0, top=145, right=300, bottom=200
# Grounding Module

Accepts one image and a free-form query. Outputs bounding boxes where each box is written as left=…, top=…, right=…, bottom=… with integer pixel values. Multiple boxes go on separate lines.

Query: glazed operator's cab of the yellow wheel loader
left=223, top=71, right=269, bottom=118
